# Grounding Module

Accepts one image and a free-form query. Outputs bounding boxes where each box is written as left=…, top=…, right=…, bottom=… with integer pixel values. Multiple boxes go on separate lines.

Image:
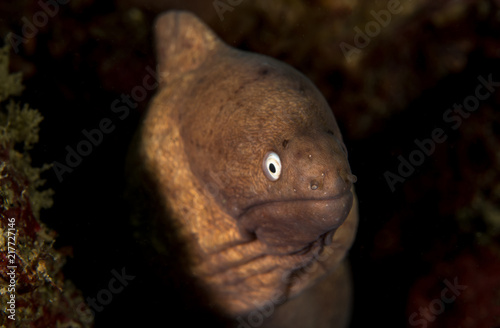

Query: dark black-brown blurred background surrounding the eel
left=0, top=0, right=500, bottom=327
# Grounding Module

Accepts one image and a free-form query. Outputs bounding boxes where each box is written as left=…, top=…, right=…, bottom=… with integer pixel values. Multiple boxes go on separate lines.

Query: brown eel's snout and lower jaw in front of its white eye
left=239, top=138, right=356, bottom=254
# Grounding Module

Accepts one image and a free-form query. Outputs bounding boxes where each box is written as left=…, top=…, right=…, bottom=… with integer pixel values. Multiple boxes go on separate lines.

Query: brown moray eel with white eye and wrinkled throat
left=129, top=11, right=358, bottom=327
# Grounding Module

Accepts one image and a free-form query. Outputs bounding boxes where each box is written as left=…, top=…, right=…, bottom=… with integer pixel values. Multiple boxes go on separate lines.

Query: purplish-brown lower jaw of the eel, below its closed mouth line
left=238, top=189, right=353, bottom=254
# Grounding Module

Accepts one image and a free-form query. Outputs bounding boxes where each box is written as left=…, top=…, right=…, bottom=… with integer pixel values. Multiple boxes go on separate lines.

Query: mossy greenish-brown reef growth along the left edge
left=0, top=42, right=92, bottom=327
